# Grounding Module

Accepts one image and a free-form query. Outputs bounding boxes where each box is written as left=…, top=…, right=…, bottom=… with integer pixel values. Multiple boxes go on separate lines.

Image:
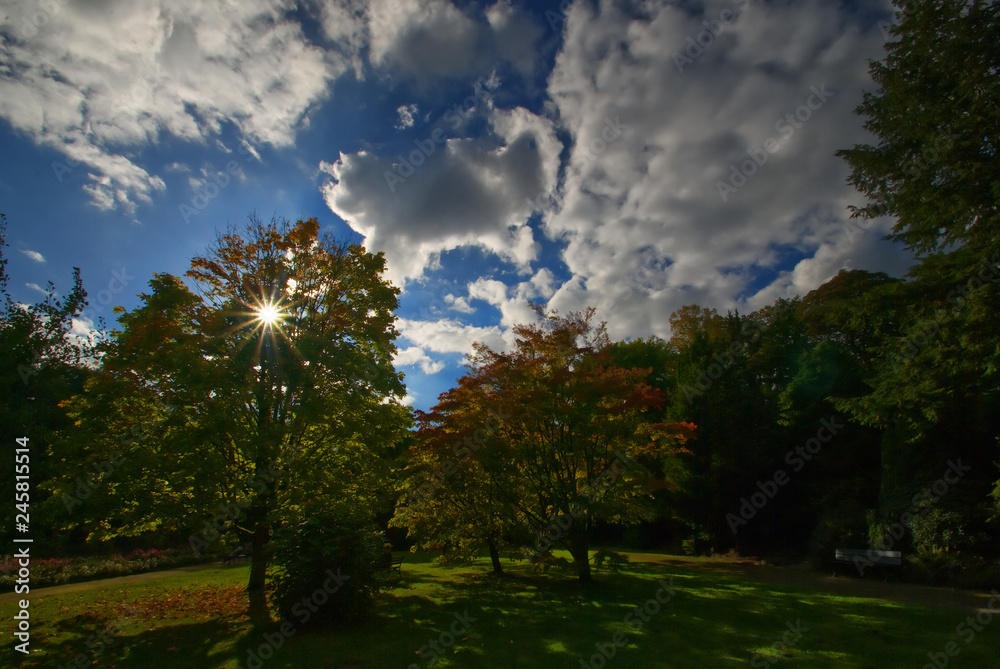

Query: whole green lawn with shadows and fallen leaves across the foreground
left=0, top=556, right=1000, bottom=669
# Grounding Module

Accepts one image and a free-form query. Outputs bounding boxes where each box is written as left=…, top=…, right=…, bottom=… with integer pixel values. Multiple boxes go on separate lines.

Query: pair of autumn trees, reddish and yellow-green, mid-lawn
left=393, top=307, right=695, bottom=581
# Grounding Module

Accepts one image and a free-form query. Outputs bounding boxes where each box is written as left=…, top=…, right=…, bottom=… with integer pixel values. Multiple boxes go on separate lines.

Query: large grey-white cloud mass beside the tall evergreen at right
left=539, top=0, right=905, bottom=336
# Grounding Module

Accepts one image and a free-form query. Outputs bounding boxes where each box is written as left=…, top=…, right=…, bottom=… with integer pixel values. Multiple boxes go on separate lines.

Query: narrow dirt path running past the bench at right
left=628, top=553, right=1000, bottom=613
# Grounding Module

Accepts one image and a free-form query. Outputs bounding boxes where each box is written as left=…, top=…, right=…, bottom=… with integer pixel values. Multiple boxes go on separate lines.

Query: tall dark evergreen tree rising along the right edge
left=838, top=0, right=1000, bottom=568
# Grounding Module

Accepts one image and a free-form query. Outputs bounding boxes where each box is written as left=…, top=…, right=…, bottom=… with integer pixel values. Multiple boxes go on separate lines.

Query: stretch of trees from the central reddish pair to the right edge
left=393, top=263, right=1000, bottom=582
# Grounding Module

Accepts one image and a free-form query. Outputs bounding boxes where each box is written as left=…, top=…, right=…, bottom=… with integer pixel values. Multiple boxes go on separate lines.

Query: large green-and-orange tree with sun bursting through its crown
left=51, top=217, right=407, bottom=623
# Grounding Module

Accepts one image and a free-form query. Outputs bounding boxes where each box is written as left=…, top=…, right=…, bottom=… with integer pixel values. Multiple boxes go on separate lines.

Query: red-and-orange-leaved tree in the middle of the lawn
left=406, top=306, right=694, bottom=581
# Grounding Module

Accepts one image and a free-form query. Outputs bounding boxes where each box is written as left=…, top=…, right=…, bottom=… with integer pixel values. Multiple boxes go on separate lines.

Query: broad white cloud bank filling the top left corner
left=0, top=0, right=340, bottom=212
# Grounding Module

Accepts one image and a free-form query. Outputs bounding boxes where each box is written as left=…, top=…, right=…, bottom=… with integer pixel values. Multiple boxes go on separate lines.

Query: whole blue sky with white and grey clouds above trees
left=0, top=0, right=912, bottom=409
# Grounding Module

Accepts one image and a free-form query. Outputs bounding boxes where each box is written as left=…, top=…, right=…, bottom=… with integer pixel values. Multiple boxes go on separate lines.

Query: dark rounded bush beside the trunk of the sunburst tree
left=268, top=514, right=389, bottom=627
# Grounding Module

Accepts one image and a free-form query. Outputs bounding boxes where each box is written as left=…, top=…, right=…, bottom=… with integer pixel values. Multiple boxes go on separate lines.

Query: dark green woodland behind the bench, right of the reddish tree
left=613, top=263, right=1000, bottom=576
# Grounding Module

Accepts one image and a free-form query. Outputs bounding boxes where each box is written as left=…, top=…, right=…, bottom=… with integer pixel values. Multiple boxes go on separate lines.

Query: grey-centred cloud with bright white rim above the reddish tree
left=320, top=107, right=562, bottom=285
